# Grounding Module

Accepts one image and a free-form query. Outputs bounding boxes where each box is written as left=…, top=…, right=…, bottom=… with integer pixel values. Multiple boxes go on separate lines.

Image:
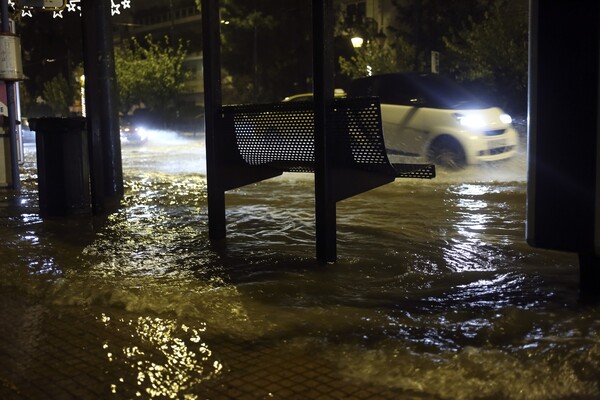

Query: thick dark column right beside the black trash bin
left=81, top=0, right=124, bottom=213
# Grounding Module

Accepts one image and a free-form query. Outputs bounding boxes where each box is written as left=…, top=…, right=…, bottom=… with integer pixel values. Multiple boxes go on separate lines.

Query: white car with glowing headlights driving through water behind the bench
left=348, top=73, right=518, bottom=168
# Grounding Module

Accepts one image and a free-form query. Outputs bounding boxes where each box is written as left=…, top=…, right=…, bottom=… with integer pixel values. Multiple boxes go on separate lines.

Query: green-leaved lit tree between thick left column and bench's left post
left=115, top=35, right=187, bottom=113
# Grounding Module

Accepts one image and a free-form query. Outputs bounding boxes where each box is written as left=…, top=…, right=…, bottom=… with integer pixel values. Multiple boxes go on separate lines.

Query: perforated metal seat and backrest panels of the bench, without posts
left=222, top=97, right=435, bottom=184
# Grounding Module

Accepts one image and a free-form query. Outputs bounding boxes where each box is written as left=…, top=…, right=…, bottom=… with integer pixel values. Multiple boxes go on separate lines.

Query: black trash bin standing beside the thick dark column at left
left=29, top=117, right=92, bottom=216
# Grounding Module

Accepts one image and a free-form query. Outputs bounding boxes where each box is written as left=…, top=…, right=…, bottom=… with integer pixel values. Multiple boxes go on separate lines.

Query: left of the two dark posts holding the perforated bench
left=202, top=0, right=226, bottom=240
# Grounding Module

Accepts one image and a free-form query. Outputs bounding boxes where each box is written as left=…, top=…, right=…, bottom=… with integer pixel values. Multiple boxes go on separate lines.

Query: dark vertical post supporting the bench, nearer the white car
left=312, top=0, right=337, bottom=262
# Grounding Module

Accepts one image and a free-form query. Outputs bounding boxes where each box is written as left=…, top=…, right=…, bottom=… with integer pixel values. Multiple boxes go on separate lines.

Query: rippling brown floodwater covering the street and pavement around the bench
left=0, top=129, right=600, bottom=399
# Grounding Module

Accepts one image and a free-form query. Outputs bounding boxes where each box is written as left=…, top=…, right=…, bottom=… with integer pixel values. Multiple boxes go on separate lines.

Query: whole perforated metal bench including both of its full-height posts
left=202, top=0, right=435, bottom=262
